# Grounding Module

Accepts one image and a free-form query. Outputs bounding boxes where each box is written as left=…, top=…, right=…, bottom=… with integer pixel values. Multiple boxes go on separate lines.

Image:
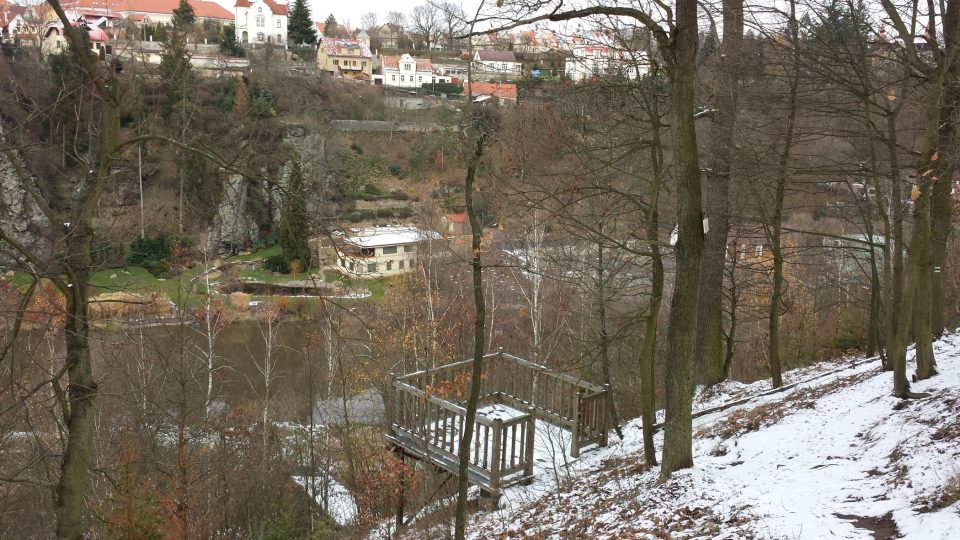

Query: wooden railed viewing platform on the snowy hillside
left=387, top=350, right=610, bottom=500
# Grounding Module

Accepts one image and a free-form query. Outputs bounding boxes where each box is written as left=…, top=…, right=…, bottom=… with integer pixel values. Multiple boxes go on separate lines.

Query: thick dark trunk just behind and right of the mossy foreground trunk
left=693, top=0, right=743, bottom=385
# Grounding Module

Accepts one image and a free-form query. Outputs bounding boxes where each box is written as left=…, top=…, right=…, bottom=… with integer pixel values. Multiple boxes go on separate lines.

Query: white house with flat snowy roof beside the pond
left=336, top=227, right=443, bottom=277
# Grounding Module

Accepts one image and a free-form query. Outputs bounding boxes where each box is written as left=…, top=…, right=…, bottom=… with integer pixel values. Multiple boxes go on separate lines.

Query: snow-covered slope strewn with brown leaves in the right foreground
left=470, top=334, right=960, bottom=540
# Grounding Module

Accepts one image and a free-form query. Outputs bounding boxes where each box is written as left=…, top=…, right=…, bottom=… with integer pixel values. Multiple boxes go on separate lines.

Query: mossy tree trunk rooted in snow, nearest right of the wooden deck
left=660, top=0, right=703, bottom=479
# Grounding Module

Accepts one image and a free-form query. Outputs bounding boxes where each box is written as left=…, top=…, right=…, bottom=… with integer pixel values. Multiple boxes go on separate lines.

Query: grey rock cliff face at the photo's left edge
left=0, top=133, right=50, bottom=257
